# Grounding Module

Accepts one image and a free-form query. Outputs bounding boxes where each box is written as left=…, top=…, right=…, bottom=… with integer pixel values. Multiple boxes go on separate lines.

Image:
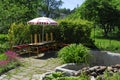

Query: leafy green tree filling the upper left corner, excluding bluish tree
left=0, top=0, right=41, bottom=33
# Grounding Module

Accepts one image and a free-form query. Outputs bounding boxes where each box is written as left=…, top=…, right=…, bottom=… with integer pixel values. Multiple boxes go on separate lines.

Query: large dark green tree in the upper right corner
left=80, top=0, right=120, bottom=36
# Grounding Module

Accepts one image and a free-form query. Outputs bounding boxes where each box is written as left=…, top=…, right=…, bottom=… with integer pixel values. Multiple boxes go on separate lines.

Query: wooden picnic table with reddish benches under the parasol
left=13, top=41, right=56, bottom=55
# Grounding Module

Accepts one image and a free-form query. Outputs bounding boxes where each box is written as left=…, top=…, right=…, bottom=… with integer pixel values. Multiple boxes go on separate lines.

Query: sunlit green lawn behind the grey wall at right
left=91, top=28, right=120, bottom=53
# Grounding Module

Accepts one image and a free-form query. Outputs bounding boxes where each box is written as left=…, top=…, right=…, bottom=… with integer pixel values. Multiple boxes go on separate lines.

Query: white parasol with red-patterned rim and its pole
left=28, top=17, right=58, bottom=41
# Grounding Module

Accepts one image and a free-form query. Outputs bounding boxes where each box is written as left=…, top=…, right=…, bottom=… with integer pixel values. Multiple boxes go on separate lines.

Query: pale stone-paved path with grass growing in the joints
left=0, top=52, right=61, bottom=80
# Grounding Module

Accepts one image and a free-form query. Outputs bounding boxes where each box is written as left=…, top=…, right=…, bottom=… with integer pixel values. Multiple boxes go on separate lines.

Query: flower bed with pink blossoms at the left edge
left=0, top=51, right=20, bottom=75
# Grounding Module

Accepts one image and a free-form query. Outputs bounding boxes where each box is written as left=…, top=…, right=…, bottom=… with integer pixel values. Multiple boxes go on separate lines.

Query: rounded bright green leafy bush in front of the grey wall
left=58, top=44, right=90, bottom=63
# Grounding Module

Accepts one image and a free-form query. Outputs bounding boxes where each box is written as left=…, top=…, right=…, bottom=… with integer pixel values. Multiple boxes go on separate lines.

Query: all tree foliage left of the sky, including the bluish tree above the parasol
left=0, top=0, right=62, bottom=33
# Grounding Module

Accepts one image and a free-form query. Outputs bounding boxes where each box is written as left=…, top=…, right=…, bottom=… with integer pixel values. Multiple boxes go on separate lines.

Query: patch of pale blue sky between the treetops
left=61, top=0, right=85, bottom=10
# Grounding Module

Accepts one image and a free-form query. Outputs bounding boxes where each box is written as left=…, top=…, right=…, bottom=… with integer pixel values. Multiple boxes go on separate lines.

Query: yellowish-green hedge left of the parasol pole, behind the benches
left=8, top=23, right=30, bottom=46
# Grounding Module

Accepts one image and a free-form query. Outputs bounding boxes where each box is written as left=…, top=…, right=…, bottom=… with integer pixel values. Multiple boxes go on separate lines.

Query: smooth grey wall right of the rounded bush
left=90, top=51, right=120, bottom=66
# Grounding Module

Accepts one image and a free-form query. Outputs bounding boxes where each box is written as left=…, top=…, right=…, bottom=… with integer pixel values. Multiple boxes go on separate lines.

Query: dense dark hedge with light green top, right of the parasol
left=59, top=19, right=95, bottom=48
